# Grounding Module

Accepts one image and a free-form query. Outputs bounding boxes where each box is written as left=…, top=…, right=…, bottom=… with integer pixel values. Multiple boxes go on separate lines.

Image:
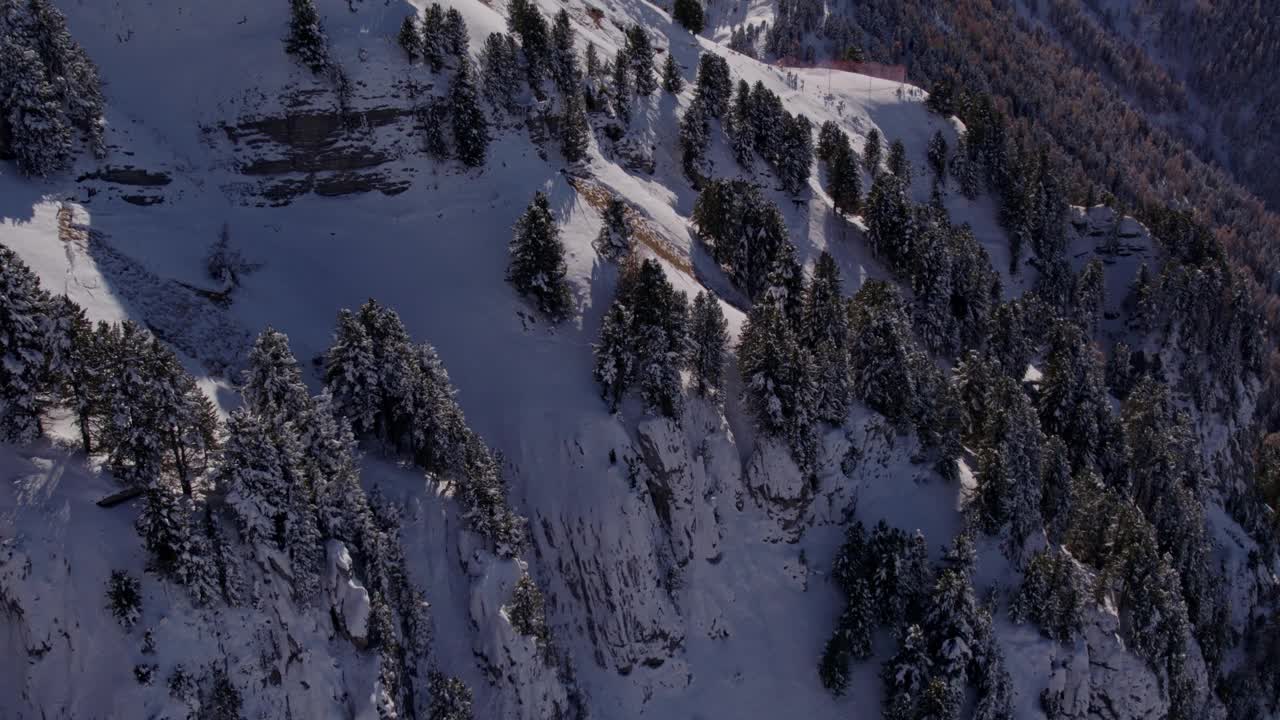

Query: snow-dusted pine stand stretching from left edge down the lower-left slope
left=0, top=246, right=483, bottom=714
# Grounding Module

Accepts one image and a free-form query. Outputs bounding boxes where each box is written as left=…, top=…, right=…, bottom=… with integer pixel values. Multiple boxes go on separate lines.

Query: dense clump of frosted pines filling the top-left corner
left=0, top=0, right=106, bottom=177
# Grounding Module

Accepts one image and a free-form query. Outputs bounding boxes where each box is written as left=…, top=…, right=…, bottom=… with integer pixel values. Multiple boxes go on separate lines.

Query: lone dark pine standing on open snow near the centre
left=507, top=191, right=572, bottom=322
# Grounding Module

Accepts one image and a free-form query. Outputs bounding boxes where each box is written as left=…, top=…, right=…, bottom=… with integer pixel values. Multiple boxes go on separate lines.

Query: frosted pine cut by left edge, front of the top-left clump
left=0, top=37, right=73, bottom=177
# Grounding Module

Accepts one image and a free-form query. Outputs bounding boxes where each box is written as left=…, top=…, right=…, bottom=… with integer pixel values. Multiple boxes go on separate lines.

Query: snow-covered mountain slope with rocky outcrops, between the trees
left=0, top=0, right=1280, bottom=719
